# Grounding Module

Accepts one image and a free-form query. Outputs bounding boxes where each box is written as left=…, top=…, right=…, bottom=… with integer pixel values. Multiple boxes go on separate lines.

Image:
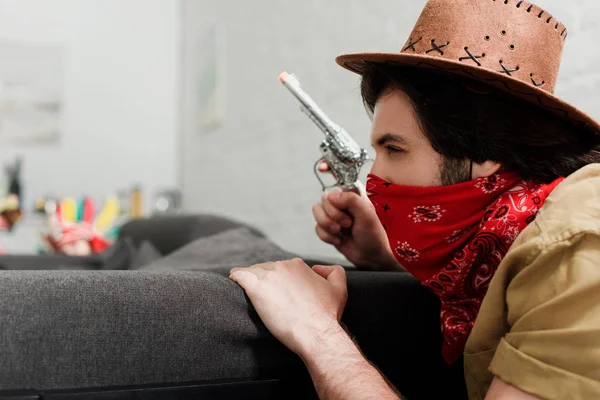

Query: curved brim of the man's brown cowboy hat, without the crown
left=335, top=53, right=600, bottom=134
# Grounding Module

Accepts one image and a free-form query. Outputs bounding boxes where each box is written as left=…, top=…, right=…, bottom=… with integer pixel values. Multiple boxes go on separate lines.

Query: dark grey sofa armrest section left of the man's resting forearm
left=0, top=271, right=302, bottom=397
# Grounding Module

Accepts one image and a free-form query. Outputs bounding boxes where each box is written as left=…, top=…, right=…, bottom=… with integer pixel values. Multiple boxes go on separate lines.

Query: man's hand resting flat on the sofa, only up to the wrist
left=229, top=259, right=348, bottom=357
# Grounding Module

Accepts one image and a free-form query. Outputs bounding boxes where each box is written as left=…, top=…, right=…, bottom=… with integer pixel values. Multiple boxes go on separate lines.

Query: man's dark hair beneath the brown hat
left=361, top=64, right=600, bottom=183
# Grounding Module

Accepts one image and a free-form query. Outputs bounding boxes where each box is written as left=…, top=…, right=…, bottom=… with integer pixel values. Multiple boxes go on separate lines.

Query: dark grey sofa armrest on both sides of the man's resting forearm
left=0, top=269, right=462, bottom=399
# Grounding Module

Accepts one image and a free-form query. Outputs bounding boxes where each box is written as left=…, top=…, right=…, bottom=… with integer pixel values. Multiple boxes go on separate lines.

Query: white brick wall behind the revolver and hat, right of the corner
left=181, top=0, right=600, bottom=256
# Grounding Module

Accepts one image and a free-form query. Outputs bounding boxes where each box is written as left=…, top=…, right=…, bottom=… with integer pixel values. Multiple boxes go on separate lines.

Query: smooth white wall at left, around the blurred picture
left=0, top=0, right=181, bottom=211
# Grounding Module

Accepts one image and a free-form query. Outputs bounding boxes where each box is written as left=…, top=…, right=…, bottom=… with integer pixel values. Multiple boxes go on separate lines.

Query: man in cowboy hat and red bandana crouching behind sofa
left=230, top=0, right=600, bottom=399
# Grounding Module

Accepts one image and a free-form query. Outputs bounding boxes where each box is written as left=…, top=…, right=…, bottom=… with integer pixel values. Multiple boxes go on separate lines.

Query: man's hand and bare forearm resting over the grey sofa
left=229, top=259, right=399, bottom=400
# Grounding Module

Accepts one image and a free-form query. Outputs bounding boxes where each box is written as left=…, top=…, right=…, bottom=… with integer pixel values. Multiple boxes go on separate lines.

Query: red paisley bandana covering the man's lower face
left=367, top=173, right=563, bottom=363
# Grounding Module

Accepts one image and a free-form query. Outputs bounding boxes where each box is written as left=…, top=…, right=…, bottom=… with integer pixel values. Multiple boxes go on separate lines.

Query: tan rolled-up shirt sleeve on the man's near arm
left=490, top=232, right=600, bottom=399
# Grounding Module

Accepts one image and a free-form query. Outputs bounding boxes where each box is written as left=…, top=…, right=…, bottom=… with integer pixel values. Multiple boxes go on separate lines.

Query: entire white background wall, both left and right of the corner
left=0, top=0, right=600, bottom=256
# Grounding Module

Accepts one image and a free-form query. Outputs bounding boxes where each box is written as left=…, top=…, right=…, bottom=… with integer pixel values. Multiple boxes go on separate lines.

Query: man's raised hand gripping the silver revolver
left=313, top=163, right=404, bottom=271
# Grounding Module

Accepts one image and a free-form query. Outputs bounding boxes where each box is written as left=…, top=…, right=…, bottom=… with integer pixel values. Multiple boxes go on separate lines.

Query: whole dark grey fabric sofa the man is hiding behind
left=0, top=216, right=464, bottom=399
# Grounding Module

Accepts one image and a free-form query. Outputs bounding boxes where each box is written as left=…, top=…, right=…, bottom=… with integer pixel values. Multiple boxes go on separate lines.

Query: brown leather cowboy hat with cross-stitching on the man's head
left=336, top=0, right=600, bottom=133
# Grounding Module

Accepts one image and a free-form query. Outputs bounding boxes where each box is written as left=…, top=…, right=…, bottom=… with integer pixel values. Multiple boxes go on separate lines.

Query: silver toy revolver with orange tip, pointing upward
left=279, top=72, right=371, bottom=193
